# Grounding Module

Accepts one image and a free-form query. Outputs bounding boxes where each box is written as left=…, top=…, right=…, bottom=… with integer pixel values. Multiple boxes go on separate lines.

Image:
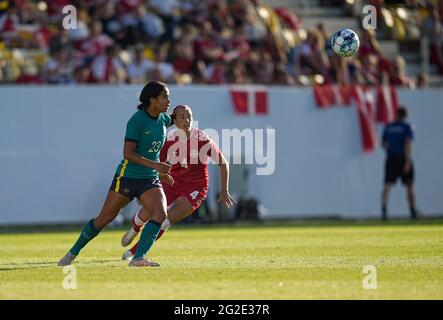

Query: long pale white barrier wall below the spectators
left=0, top=86, right=443, bottom=225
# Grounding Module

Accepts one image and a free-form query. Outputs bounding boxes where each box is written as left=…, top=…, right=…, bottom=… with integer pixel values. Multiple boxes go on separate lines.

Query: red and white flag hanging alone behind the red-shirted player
left=230, top=87, right=268, bottom=115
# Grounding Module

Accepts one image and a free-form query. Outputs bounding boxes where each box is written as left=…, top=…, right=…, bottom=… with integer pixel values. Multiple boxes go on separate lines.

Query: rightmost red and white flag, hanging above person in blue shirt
left=376, top=86, right=398, bottom=123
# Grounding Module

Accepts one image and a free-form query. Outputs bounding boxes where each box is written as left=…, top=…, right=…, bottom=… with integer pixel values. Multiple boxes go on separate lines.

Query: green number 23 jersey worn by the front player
left=115, top=110, right=172, bottom=180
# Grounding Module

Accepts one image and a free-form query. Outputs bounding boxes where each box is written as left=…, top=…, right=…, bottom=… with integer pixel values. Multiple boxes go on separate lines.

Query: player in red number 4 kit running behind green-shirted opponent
left=121, top=105, right=235, bottom=259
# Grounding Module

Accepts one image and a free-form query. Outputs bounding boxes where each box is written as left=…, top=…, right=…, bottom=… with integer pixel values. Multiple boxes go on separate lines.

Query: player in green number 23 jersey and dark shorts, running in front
left=58, top=81, right=172, bottom=267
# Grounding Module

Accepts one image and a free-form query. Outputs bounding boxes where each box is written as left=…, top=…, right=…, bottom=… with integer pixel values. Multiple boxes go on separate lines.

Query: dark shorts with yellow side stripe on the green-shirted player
left=109, top=176, right=162, bottom=200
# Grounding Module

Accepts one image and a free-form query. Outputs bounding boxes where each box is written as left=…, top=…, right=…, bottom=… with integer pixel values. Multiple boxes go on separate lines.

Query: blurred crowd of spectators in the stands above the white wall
left=0, top=0, right=443, bottom=87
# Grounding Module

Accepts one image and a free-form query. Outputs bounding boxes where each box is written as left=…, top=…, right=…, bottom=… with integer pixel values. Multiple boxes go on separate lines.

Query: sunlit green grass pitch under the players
left=0, top=220, right=443, bottom=299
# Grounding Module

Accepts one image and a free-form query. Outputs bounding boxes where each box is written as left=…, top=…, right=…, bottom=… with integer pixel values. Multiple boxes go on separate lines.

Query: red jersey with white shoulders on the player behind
left=160, top=129, right=220, bottom=189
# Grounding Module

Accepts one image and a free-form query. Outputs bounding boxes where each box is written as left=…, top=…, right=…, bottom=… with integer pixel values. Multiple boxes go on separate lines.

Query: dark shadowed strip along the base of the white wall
left=0, top=216, right=443, bottom=235
